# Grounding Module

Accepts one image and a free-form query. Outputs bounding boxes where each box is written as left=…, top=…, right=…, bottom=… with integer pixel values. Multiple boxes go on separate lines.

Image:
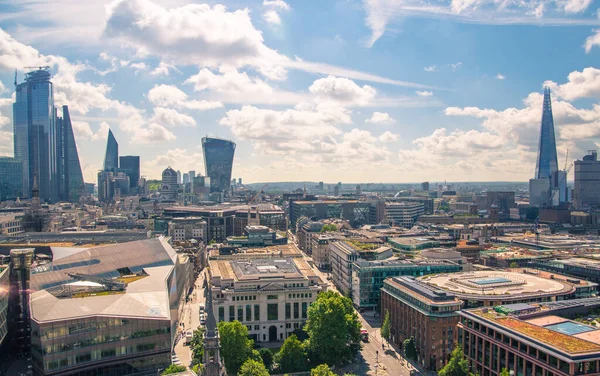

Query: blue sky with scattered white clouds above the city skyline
left=0, top=0, right=600, bottom=183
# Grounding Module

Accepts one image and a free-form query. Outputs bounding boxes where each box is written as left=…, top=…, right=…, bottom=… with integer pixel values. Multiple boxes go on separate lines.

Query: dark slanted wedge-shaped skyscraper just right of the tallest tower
left=57, top=106, right=85, bottom=202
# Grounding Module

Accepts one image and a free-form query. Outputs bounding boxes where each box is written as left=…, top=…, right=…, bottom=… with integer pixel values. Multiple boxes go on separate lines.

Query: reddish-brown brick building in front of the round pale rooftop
left=381, top=276, right=462, bottom=372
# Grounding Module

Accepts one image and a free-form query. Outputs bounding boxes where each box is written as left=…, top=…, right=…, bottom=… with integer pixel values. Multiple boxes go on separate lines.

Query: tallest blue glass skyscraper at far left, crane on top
left=13, top=68, right=59, bottom=201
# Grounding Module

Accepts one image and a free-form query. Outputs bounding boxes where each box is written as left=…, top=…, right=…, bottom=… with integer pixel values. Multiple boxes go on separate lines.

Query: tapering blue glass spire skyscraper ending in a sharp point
left=535, top=88, right=558, bottom=179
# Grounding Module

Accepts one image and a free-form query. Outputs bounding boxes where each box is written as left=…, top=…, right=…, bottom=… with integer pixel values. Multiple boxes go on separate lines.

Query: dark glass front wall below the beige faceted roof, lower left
left=31, top=317, right=171, bottom=376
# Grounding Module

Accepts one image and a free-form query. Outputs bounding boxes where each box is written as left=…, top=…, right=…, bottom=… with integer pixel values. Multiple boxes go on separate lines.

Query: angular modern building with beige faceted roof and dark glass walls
left=30, top=238, right=193, bottom=376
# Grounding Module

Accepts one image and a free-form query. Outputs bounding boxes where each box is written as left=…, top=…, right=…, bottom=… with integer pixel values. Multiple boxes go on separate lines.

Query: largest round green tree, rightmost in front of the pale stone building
left=304, top=291, right=361, bottom=365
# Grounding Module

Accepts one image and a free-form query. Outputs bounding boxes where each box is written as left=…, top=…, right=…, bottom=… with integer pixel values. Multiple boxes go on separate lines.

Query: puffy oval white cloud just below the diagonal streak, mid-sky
left=308, top=76, right=377, bottom=105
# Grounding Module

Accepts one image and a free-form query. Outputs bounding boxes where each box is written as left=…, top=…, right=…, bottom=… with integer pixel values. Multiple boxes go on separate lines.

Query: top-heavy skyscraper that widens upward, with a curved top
left=202, top=137, right=235, bottom=195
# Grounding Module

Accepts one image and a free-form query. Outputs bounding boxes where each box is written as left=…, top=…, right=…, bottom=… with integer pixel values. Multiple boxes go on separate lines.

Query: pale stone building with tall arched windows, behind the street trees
left=209, top=256, right=327, bottom=342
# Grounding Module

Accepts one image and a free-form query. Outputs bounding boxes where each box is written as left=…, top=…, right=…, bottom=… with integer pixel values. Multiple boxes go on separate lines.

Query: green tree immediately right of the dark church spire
left=218, top=320, right=254, bottom=375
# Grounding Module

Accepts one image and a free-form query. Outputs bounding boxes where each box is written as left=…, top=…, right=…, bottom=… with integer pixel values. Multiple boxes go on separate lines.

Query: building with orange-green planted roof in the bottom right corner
left=457, top=298, right=600, bottom=376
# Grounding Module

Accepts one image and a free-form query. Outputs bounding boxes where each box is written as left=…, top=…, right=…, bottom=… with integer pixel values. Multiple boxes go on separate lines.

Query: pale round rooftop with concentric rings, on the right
left=419, top=270, right=575, bottom=300
